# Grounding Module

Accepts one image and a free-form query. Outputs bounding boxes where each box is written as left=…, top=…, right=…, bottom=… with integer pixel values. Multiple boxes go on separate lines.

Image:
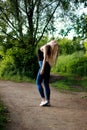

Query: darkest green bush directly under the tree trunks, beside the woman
left=13, top=46, right=38, bottom=78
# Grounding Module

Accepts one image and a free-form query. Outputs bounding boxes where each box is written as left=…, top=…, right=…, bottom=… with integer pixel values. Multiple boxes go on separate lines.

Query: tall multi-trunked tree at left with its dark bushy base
left=0, top=0, right=86, bottom=78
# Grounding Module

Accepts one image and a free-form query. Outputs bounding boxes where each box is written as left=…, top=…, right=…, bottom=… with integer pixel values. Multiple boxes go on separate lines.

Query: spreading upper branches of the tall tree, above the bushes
left=0, top=0, right=86, bottom=45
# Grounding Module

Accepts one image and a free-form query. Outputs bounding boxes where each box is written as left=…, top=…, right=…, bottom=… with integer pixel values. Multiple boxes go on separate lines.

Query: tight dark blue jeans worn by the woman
left=36, top=61, right=50, bottom=100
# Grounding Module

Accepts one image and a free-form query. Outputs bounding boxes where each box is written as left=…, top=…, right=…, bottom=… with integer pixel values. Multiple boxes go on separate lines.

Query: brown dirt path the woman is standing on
left=0, top=81, right=87, bottom=130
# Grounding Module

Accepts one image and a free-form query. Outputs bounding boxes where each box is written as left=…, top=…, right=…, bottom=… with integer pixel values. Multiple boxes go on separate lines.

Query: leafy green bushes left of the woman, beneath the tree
left=0, top=46, right=38, bottom=79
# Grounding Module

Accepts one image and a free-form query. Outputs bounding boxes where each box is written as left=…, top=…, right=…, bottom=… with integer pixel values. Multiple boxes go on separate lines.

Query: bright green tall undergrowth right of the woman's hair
left=52, top=52, right=87, bottom=76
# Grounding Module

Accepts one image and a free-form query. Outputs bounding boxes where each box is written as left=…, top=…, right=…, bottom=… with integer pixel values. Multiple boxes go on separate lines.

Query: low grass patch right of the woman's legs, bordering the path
left=52, top=75, right=87, bottom=92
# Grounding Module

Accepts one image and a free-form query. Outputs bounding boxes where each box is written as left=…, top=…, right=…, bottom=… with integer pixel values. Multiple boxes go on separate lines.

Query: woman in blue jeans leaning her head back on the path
left=36, top=41, right=59, bottom=106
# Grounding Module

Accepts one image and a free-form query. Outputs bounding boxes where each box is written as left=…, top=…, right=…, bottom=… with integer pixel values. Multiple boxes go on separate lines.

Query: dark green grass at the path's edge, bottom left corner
left=0, top=101, right=8, bottom=130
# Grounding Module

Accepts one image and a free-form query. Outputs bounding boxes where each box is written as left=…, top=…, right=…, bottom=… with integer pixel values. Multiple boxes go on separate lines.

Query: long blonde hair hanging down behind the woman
left=47, top=43, right=59, bottom=66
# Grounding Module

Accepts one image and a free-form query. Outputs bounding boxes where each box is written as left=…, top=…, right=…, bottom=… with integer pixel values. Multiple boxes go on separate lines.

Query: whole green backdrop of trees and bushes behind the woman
left=0, top=0, right=87, bottom=81
